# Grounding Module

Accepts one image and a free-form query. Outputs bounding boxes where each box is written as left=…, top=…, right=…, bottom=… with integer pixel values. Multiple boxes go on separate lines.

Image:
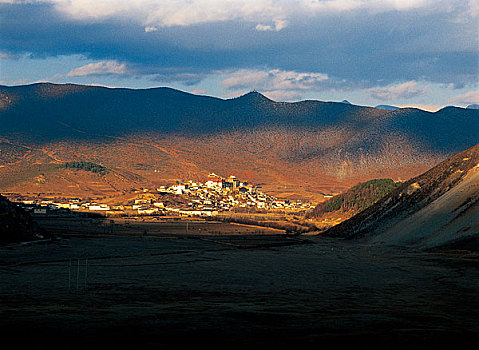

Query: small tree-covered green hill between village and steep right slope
left=305, top=179, right=401, bottom=227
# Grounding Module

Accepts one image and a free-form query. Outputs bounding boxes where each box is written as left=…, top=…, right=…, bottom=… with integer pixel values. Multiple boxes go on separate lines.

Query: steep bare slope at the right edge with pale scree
left=325, top=144, right=479, bottom=250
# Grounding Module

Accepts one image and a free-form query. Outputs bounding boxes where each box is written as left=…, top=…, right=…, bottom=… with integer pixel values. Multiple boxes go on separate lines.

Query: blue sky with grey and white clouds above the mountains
left=0, top=0, right=479, bottom=111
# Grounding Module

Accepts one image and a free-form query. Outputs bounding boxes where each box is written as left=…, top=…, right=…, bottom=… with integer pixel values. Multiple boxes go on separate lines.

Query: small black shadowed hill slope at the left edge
left=0, top=195, right=51, bottom=244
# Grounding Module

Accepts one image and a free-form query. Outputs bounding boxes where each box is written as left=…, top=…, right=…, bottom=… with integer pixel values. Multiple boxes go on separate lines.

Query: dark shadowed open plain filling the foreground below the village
left=0, top=218, right=479, bottom=349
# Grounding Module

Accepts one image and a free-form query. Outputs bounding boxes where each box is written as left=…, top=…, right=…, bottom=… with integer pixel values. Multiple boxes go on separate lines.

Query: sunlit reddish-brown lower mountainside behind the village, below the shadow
left=0, top=133, right=439, bottom=202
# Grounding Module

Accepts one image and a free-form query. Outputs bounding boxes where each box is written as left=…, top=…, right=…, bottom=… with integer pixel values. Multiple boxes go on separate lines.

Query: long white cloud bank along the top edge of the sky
left=42, top=0, right=464, bottom=31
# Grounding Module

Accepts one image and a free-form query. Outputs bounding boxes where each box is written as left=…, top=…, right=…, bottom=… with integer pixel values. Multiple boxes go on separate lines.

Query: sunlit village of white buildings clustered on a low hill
left=6, top=173, right=313, bottom=217
